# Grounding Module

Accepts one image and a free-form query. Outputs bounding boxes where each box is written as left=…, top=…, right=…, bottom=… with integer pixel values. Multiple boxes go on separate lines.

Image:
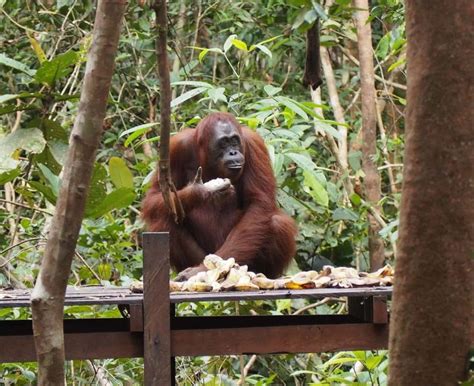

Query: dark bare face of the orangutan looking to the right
left=209, top=121, right=245, bottom=181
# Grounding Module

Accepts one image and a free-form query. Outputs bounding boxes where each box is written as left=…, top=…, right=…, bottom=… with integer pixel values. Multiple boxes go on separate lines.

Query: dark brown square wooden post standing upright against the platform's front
left=143, top=232, right=171, bottom=386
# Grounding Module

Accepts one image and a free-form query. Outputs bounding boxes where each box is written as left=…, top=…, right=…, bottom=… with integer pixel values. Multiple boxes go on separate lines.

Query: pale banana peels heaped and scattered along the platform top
left=131, top=255, right=393, bottom=292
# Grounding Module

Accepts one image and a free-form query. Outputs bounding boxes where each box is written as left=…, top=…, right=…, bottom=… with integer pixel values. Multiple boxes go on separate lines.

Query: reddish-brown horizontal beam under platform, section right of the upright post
left=171, top=323, right=388, bottom=356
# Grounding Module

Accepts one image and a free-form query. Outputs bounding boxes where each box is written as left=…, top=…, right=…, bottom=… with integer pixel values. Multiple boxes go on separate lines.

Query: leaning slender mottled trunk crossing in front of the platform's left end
left=31, top=0, right=127, bottom=385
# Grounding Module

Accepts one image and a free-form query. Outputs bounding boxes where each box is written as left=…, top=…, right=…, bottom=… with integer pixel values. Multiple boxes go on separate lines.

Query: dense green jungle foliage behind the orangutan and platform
left=0, top=0, right=406, bottom=385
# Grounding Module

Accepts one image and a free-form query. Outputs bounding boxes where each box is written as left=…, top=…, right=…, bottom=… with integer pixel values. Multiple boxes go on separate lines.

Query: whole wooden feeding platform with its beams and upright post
left=0, top=233, right=392, bottom=385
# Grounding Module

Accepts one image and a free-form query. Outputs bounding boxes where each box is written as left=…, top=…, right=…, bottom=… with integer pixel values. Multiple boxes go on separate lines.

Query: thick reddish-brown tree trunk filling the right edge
left=389, top=0, right=474, bottom=386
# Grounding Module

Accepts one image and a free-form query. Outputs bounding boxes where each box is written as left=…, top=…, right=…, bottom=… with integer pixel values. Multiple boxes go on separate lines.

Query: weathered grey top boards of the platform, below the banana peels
left=0, top=286, right=392, bottom=308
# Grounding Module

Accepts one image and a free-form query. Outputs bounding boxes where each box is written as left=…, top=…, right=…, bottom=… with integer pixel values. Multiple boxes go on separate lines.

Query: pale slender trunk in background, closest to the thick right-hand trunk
left=353, top=0, right=384, bottom=271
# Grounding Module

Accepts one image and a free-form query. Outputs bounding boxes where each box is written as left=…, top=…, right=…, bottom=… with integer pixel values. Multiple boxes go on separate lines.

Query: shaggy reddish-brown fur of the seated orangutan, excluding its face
left=142, top=113, right=296, bottom=277
